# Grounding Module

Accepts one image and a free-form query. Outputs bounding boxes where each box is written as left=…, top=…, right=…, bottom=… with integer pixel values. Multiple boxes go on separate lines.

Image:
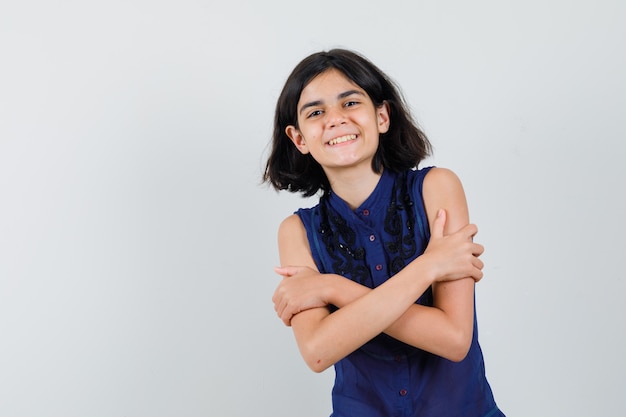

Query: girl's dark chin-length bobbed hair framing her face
left=263, top=49, right=432, bottom=197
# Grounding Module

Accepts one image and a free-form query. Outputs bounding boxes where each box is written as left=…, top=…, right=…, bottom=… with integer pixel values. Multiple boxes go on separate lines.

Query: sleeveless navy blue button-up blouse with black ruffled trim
left=297, top=168, right=504, bottom=417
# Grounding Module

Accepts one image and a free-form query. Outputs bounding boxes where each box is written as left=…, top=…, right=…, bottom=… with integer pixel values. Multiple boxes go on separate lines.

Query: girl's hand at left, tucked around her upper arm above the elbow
left=272, top=266, right=328, bottom=326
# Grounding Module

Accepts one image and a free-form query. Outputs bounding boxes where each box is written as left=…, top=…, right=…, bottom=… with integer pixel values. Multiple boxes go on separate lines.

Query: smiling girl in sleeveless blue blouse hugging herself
left=264, top=49, right=504, bottom=417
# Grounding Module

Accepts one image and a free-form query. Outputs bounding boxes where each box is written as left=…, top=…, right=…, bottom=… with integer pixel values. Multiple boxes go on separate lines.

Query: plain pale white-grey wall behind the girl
left=0, top=0, right=626, bottom=417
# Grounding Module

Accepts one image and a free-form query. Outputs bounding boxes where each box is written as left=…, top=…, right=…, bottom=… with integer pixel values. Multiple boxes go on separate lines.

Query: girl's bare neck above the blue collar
left=326, top=166, right=382, bottom=210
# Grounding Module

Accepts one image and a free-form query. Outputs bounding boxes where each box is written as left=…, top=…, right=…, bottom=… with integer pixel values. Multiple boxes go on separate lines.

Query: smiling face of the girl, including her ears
left=285, top=69, right=389, bottom=175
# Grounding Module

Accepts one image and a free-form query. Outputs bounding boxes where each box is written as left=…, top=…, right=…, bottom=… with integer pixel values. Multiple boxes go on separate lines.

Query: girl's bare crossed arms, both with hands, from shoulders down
left=272, top=168, right=483, bottom=372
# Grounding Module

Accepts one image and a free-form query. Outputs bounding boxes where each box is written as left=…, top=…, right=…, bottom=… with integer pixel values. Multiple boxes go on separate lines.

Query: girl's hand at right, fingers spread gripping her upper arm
left=422, top=209, right=485, bottom=282
